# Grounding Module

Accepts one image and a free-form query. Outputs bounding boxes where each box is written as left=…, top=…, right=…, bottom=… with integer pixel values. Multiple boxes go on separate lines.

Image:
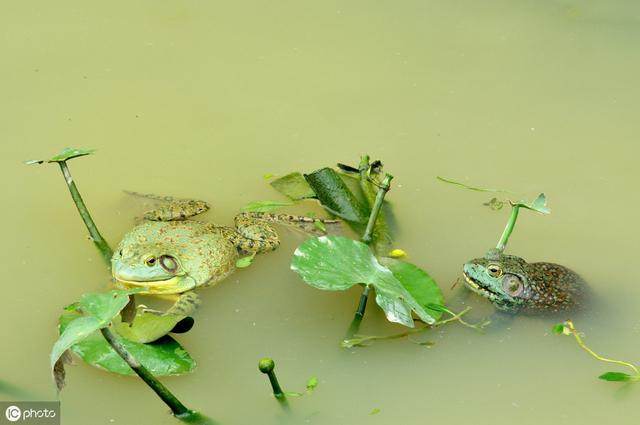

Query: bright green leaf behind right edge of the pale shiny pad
left=384, top=259, right=444, bottom=320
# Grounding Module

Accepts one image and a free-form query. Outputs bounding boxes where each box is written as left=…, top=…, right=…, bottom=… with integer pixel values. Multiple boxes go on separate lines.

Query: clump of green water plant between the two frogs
left=258, top=155, right=484, bottom=347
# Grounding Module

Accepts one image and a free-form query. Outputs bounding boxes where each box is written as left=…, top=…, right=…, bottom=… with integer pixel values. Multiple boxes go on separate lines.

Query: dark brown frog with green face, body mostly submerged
left=463, top=250, right=586, bottom=314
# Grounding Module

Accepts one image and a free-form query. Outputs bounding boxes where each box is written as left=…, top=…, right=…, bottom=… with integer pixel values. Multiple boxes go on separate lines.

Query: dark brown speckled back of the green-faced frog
left=522, top=262, right=589, bottom=314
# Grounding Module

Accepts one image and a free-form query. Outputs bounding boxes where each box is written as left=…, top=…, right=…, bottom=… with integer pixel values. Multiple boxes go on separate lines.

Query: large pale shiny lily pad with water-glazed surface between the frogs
left=291, top=235, right=435, bottom=327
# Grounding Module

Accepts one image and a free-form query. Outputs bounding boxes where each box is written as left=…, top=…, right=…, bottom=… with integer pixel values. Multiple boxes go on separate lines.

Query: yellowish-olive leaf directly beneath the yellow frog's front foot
left=113, top=309, right=187, bottom=344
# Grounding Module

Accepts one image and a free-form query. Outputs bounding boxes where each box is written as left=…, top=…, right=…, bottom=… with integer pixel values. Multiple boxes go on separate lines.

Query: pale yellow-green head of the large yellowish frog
left=111, top=241, right=196, bottom=294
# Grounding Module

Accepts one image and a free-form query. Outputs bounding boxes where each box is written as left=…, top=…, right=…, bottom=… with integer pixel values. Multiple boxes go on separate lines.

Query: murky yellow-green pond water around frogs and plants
left=0, top=1, right=640, bottom=425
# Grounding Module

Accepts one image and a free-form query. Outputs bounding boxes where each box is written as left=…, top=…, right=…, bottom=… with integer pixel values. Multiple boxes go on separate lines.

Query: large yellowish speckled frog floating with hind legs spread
left=111, top=193, right=337, bottom=316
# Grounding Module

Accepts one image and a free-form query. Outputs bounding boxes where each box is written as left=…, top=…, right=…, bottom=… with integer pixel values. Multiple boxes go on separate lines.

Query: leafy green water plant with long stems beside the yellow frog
left=25, top=148, right=212, bottom=424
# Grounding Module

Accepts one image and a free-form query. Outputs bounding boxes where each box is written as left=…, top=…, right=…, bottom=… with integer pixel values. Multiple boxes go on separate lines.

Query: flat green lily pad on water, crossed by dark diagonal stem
left=60, top=311, right=196, bottom=376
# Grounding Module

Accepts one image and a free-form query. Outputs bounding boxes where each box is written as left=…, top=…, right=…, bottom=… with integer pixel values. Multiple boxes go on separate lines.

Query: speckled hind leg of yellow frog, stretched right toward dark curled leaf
left=233, top=212, right=340, bottom=254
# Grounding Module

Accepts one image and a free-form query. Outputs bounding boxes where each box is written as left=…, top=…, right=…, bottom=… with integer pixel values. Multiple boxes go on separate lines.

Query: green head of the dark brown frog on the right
left=463, top=250, right=531, bottom=312
